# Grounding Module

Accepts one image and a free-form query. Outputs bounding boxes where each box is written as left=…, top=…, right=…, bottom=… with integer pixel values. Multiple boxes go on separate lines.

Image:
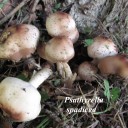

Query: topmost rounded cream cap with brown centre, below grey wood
left=46, top=12, right=76, bottom=37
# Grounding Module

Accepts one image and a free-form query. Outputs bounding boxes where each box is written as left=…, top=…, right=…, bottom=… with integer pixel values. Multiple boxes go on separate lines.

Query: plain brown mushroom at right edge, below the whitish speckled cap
left=98, top=55, right=128, bottom=78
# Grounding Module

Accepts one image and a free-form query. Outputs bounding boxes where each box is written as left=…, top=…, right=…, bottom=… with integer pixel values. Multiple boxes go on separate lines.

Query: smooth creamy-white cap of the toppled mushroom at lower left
left=0, top=77, right=41, bottom=122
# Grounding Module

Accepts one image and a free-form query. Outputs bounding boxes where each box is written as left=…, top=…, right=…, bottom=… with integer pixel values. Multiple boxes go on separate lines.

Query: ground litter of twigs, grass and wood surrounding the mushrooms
left=0, top=0, right=128, bottom=128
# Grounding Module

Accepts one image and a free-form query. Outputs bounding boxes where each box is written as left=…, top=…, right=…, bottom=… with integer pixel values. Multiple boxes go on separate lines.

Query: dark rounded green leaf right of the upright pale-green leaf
left=110, top=87, right=120, bottom=102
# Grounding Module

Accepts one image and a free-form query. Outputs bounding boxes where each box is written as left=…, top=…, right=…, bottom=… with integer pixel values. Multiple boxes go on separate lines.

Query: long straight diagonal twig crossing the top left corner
left=0, top=0, right=30, bottom=25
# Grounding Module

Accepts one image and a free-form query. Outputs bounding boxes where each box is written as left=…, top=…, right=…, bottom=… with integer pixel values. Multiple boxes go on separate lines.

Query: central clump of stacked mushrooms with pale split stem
left=37, top=12, right=79, bottom=79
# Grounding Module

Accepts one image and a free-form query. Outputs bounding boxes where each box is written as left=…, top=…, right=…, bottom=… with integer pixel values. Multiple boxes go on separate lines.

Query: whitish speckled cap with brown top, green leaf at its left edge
left=87, top=36, right=118, bottom=59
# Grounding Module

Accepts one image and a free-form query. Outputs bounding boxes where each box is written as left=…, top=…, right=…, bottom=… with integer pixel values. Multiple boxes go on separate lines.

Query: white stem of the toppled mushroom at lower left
left=29, top=67, right=53, bottom=88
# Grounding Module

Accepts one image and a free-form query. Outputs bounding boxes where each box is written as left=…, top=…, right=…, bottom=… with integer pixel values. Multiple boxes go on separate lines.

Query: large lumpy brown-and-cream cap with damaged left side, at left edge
left=0, top=24, right=39, bottom=61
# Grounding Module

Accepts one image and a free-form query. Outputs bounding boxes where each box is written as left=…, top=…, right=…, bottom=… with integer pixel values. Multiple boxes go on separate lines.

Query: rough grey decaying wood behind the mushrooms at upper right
left=65, top=0, right=128, bottom=43
